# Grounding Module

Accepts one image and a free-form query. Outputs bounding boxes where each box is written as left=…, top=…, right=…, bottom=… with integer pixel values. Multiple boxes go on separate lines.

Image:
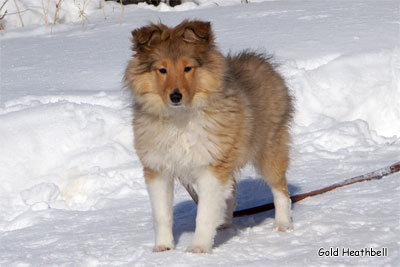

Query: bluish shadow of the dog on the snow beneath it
left=173, top=178, right=300, bottom=250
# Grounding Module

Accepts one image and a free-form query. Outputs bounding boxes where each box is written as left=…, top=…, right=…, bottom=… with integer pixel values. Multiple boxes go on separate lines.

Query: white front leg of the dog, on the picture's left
left=145, top=168, right=174, bottom=252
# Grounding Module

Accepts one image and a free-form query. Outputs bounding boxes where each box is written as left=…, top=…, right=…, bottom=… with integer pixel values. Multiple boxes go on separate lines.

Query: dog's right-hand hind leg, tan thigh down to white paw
left=256, top=129, right=293, bottom=232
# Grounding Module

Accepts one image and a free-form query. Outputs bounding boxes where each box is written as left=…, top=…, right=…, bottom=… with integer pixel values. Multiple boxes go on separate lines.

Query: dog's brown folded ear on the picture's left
left=132, top=24, right=163, bottom=53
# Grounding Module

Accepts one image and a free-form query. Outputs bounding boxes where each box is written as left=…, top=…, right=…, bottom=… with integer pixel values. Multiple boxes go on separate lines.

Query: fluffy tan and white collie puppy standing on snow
left=124, top=20, right=293, bottom=253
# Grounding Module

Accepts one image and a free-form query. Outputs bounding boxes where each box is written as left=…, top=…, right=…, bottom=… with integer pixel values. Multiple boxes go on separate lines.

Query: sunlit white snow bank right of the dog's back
left=283, top=49, right=400, bottom=137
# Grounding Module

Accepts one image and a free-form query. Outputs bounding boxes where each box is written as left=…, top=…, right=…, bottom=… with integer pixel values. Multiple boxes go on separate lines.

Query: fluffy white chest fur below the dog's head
left=142, top=115, right=216, bottom=178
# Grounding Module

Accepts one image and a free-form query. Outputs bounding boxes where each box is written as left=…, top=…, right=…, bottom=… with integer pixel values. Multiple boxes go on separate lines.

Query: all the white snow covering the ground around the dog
left=0, top=0, right=400, bottom=266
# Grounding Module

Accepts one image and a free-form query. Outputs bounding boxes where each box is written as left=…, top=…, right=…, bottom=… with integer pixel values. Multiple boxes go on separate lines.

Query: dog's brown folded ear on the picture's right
left=179, top=20, right=214, bottom=44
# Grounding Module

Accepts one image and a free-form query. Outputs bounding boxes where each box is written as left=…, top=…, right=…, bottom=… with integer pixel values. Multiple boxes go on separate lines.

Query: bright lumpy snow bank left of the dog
left=0, top=93, right=143, bottom=230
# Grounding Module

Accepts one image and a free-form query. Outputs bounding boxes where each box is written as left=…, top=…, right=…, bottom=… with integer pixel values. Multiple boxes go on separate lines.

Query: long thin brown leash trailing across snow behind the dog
left=233, top=161, right=400, bottom=217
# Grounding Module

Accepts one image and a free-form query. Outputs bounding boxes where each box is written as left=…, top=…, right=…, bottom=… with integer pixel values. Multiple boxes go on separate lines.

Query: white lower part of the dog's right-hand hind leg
left=271, top=188, right=293, bottom=232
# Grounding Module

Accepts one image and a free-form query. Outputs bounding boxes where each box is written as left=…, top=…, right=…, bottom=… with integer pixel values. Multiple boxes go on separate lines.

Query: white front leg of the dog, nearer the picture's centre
left=187, top=169, right=233, bottom=253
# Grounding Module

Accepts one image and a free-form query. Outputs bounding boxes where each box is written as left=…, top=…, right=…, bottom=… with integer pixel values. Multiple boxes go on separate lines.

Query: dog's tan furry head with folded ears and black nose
left=125, top=20, right=224, bottom=113
